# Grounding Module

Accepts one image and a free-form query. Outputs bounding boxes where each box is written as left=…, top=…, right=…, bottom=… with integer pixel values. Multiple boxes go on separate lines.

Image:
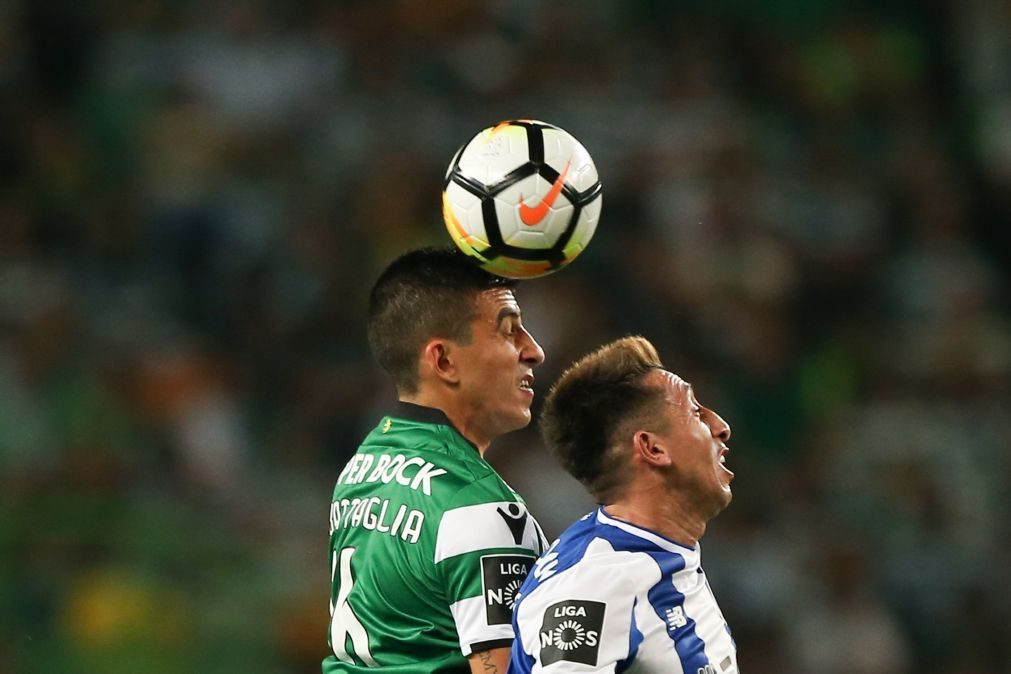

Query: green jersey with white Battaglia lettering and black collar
left=323, top=403, right=546, bottom=674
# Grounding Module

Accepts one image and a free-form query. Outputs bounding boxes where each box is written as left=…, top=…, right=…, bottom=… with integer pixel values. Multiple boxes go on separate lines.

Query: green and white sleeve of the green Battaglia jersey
left=435, top=476, right=544, bottom=656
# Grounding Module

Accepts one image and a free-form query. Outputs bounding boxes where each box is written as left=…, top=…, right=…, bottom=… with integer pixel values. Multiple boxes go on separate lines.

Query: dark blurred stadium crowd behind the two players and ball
left=0, top=0, right=1011, bottom=674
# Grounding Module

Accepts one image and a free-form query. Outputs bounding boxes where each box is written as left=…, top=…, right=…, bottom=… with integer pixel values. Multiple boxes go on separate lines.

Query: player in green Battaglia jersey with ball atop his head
left=323, top=249, right=546, bottom=674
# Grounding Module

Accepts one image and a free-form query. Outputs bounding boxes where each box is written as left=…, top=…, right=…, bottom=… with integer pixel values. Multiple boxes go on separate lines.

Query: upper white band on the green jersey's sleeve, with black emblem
left=435, top=501, right=544, bottom=564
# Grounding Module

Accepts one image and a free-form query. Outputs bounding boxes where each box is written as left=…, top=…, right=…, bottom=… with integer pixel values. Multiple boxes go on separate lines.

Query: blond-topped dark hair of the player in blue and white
left=540, top=336, right=665, bottom=503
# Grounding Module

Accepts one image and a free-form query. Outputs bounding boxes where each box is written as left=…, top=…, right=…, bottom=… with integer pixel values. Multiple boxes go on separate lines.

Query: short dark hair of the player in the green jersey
left=368, top=247, right=518, bottom=393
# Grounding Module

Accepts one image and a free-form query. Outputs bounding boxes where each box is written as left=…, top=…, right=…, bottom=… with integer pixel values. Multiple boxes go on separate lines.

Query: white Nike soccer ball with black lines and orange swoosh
left=443, top=119, right=603, bottom=279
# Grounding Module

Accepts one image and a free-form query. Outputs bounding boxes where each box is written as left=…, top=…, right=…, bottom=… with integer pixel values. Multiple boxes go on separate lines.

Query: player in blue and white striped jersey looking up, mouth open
left=509, top=336, right=739, bottom=674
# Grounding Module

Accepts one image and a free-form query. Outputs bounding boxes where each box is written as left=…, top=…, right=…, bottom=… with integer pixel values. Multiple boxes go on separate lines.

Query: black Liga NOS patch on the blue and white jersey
left=539, top=599, right=607, bottom=666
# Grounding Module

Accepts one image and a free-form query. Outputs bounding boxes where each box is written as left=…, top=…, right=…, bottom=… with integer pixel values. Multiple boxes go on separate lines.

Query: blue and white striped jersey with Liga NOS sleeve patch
left=509, top=507, right=738, bottom=674
